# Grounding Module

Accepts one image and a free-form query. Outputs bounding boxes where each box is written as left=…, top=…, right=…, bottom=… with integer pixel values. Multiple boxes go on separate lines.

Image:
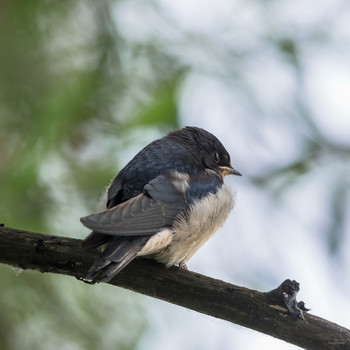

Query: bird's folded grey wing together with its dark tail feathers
left=80, top=175, right=188, bottom=282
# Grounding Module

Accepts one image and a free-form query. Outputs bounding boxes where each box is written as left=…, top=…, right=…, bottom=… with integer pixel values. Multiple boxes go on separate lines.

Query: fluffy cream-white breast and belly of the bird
left=151, top=184, right=234, bottom=267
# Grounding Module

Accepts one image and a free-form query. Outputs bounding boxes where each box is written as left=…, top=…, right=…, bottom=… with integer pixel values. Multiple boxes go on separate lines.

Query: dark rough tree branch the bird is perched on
left=0, top=227, right=350, bottom=350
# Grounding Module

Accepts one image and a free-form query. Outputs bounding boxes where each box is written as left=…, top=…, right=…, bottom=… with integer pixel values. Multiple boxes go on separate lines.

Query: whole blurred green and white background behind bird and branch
left=0, top=0, right=350, bottom=350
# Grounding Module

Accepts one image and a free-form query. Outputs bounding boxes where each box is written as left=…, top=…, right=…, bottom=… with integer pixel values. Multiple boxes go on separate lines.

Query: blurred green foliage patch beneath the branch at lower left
left=0, top=268, right=145, bottom=350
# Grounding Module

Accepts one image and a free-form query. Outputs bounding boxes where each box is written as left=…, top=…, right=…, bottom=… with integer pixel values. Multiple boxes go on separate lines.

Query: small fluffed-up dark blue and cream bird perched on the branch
left=80, top=126, right=242, bottom=282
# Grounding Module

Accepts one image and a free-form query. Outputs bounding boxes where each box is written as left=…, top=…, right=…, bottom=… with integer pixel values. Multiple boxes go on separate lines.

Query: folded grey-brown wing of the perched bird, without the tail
left=80, top=175, right=186, bottom=239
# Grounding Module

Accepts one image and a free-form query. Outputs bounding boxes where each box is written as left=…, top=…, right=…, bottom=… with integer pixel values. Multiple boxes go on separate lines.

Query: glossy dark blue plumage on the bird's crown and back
left=107, top=127, right=230, bottom=208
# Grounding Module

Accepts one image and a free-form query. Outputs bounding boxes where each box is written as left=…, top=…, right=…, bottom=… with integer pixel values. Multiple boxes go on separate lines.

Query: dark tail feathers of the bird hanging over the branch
left=86, top=236, right=149, bottom=282
